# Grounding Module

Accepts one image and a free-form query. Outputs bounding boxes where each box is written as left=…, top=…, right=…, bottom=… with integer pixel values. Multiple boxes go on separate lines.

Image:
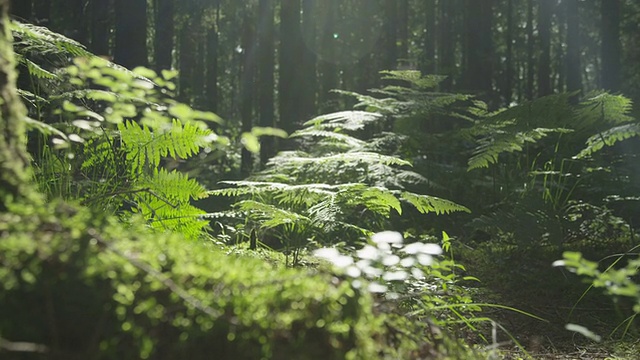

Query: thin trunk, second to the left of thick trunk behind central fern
left=240, top=7, right=256, bottom=177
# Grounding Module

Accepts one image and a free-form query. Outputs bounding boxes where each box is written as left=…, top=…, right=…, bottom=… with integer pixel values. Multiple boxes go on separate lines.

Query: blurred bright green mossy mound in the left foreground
left=0, top=202, right=403, bottom=359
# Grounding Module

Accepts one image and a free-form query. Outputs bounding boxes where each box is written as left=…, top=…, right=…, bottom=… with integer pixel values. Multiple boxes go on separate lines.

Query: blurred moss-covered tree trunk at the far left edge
left=0, top=0, right=36, bottom=211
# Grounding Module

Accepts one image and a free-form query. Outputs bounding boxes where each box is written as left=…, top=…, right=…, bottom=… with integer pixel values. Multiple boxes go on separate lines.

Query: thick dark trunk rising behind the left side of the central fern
left=279, top=0, right=304, bottom=141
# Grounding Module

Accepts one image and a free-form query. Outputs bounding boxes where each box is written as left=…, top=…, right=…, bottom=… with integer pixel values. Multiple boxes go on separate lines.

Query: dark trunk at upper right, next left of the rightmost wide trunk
left=565, top=0, right=582, bottom=95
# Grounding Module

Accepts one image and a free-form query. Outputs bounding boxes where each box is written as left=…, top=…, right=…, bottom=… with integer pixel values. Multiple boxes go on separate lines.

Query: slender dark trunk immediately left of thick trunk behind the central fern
left=258, top=0, right=275, bottom=165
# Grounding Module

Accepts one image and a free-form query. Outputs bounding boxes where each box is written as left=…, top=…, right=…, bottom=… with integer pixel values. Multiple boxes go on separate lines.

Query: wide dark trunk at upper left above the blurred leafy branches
left=113, top=0, right=148, bottom=69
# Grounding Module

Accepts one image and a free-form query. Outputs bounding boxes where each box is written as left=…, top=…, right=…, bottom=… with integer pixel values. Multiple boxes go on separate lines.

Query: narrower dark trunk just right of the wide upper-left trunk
left=153, top=0, right=175, bottom=71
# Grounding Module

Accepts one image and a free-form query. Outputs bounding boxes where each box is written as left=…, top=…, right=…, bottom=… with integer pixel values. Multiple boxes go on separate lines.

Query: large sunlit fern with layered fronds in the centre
left=210, top=104, right=468, bottom=260
